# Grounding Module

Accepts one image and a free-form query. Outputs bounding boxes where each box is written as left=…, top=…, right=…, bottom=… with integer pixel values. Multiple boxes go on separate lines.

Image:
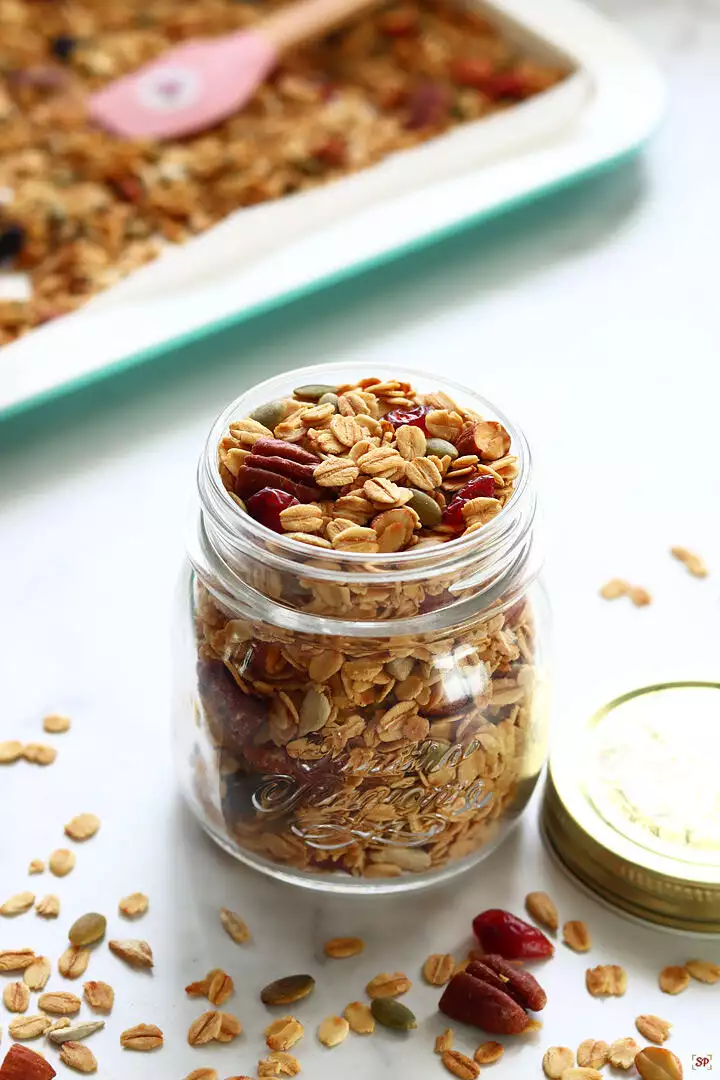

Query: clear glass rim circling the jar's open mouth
left=198, top=361, right=531, bottom=578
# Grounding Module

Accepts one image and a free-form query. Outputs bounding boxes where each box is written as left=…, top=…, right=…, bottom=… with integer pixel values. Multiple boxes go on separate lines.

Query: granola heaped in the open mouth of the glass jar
left=219, top=378, right=517, bottom=554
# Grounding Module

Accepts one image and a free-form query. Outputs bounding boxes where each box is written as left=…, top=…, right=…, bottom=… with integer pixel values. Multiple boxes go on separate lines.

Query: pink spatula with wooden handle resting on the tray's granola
left=89, top=0, right=380, bottom=139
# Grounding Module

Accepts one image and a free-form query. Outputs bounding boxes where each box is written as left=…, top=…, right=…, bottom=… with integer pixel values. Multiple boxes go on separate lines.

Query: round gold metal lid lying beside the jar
left=542, top=683, right=720, bottom=934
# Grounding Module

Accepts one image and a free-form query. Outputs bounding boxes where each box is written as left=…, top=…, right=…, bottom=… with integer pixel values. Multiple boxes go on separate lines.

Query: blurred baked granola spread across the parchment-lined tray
left=0, top=0, right=565, bottom=346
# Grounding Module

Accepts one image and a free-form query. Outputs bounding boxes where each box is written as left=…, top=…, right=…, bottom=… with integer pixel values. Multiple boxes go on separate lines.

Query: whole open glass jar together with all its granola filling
left=177, top=365, right=546, bottom=891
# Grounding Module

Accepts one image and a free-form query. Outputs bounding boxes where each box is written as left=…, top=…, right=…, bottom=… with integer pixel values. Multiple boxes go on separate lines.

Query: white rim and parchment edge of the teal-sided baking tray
left=0, top=0, right=665, bottom=419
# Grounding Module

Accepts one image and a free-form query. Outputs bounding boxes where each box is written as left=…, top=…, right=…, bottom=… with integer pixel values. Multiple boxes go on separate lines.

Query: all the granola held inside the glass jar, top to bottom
left=188, top=371, right=537, bottom=878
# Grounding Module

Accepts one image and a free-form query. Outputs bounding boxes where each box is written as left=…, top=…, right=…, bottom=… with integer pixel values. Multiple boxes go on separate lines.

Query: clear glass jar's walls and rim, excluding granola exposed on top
left=174, top=364, right=547, bottom=893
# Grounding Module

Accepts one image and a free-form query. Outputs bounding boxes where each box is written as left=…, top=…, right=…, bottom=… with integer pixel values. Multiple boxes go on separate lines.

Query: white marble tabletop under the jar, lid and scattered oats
left=0, top=0, right=720, bottom=1080
